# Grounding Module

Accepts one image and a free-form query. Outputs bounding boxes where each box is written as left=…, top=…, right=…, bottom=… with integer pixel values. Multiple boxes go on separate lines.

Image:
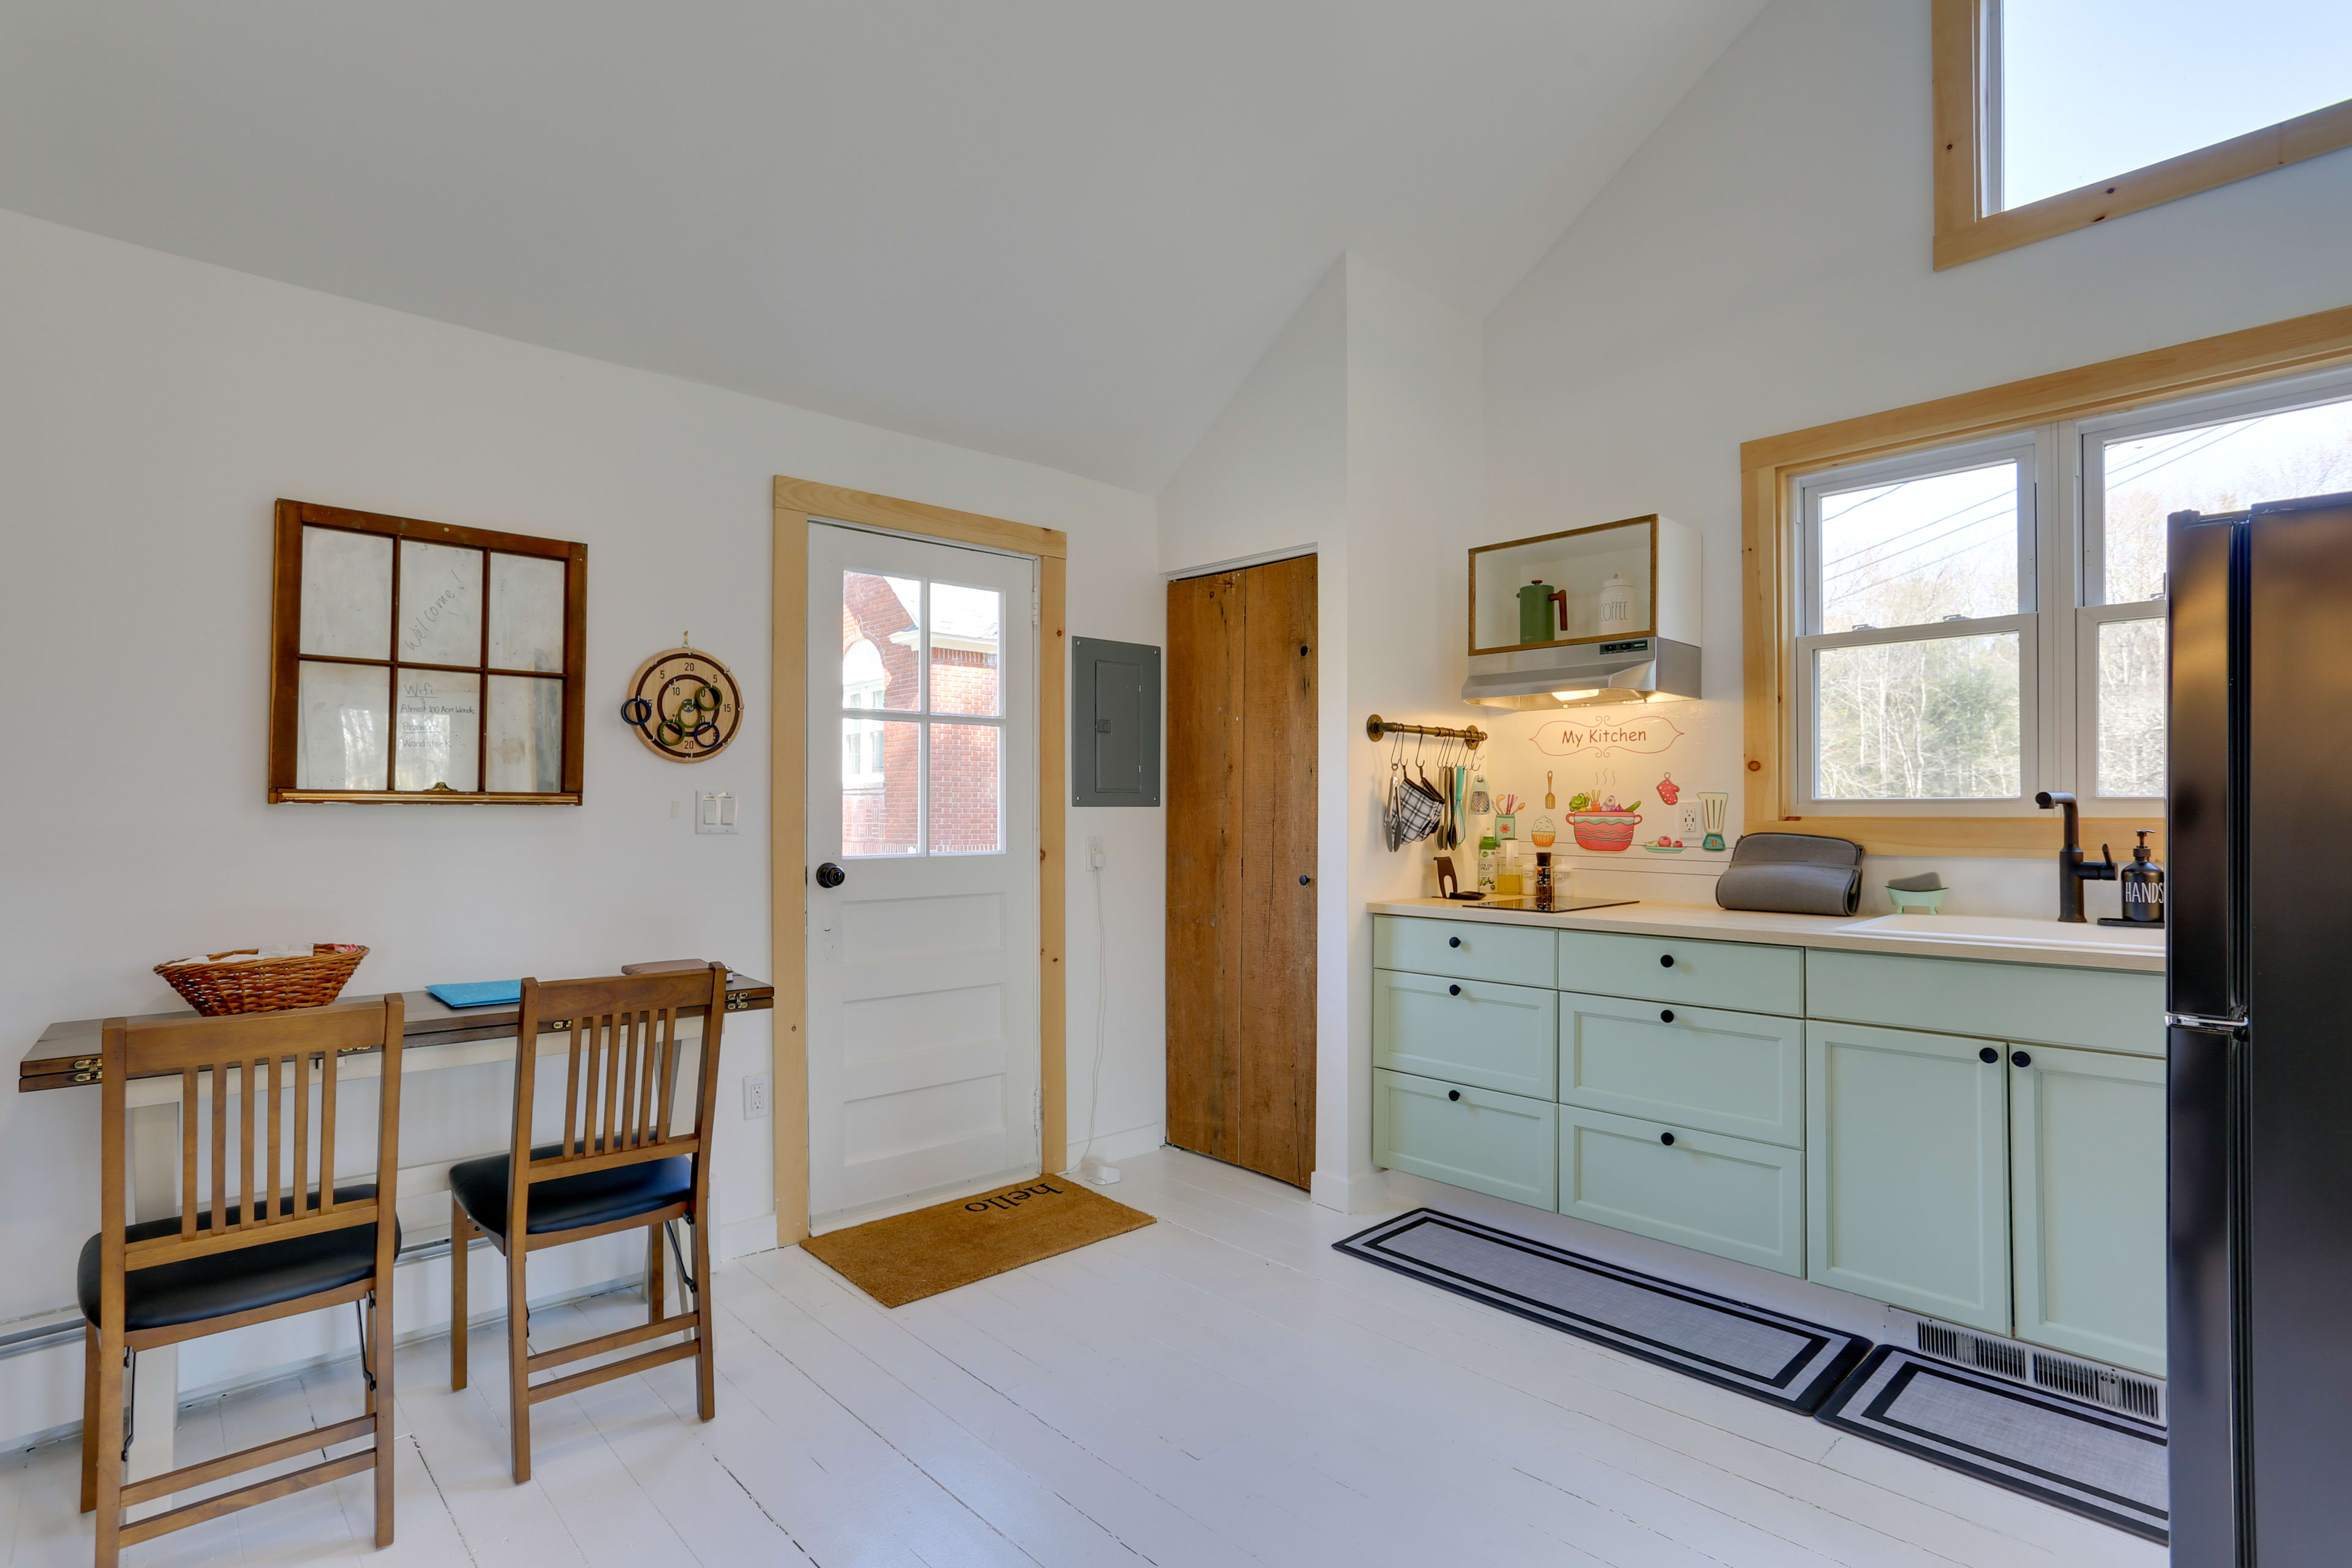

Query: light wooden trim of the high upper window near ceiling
left=1933, top=0, right=2352, bottom=273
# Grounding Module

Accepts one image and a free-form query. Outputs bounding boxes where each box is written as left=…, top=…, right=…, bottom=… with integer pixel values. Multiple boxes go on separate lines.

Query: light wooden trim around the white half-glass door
left=769, top=475, right=1070, bottom=1246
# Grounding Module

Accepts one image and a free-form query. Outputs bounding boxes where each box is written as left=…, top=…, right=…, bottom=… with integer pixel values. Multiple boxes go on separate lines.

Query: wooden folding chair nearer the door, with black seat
left=449, top=964, right=727, bottom=1483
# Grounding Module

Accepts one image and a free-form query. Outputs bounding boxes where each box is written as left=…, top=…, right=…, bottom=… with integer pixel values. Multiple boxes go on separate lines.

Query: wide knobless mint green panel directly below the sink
left=1804, top=948, right=2164, bottom=1055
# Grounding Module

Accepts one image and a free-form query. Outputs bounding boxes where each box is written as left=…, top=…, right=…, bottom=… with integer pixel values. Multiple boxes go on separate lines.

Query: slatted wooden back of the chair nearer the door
left=508, top=964, right=727, bottom=1204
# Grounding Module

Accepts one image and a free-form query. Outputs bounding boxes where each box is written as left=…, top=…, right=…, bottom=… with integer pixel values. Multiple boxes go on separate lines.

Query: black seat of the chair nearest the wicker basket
left=73, top=1185, right=400, bottom=1333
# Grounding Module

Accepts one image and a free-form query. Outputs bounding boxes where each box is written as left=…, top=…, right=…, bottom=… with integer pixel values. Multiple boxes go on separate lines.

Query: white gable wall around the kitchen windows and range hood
left=1461, top=0, right=2352, bottom=914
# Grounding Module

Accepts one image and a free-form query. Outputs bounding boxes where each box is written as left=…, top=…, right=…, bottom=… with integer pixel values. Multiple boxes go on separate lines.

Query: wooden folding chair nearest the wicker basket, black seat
left=75, top=995, right=402, bottom=1568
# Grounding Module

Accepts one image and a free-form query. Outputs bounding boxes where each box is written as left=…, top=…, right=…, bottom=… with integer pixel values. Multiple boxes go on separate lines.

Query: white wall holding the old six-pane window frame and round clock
left=0, top=214, right=1164, bottom=1434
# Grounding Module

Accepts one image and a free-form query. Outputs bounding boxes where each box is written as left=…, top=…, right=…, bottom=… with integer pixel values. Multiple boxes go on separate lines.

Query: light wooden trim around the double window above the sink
left=1741, top=306, right=2352, bottom=856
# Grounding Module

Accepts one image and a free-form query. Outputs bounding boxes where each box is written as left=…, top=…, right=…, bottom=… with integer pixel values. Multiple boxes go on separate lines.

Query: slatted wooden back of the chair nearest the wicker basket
left=101, top=995, right=402, bottom=1270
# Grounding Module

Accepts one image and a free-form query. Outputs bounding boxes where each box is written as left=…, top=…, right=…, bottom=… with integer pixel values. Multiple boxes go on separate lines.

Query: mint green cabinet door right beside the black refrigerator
left=2008, top=1046, right=2164, bottom=1378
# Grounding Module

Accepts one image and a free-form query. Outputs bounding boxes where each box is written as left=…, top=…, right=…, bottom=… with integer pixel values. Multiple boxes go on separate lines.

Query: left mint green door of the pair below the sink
left=1804, top=1023, right=2011, bottom=1335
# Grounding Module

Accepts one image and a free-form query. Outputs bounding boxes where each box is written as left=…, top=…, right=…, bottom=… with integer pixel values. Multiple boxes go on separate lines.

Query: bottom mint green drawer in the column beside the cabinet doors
left=1559, top=1105, right=1804, bottom=1279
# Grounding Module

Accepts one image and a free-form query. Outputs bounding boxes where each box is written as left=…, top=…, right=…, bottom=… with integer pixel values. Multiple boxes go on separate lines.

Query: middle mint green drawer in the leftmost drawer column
left=1371, top=968, right=1559, bottom=1100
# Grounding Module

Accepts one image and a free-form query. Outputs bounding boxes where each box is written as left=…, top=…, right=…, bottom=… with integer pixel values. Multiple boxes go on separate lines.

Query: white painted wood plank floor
left=0, top=1150, right=2166, bottom=1568
